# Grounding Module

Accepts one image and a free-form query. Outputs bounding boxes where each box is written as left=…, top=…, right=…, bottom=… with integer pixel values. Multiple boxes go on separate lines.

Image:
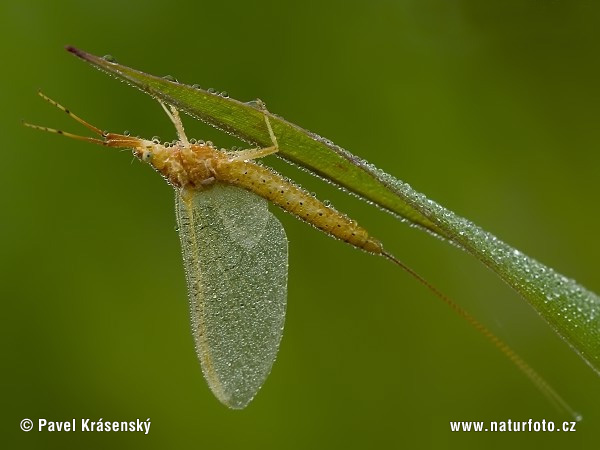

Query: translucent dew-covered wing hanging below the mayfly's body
left=175, top=184, right=287, bottom=409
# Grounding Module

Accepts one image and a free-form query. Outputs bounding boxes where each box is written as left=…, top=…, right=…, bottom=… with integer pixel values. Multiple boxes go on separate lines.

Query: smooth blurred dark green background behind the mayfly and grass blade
left=0, top=0, right=600, bottom=449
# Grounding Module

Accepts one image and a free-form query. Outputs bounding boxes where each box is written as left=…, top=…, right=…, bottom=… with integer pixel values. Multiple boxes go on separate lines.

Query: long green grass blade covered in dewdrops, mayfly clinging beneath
left=67, top=47, right=600, bottom=374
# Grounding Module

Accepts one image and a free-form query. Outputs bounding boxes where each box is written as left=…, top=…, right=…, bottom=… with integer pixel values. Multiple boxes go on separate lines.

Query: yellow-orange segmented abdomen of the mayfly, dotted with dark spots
left=215, top=160, right=383, bottom=253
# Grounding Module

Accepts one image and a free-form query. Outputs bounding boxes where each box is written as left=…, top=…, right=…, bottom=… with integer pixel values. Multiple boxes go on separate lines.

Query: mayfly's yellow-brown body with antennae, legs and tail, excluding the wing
left=25, top=93, right=581, bottom=421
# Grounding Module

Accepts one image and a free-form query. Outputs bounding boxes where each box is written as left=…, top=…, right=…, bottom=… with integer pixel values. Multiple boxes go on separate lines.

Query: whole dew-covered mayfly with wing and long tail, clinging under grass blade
left=25, top=92, right=576, bottom=416
